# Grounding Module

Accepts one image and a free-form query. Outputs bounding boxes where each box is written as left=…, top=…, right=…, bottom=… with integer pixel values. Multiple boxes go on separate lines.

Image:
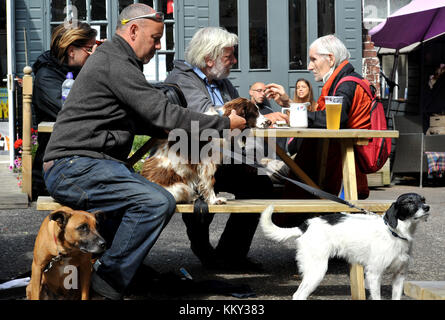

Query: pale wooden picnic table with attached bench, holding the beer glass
left=38, top=122, right=399, bottom=300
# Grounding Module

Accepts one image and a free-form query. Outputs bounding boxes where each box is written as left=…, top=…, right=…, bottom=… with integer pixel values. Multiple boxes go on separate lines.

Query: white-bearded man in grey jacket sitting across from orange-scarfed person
left=165, top=27, right=273, bottom=270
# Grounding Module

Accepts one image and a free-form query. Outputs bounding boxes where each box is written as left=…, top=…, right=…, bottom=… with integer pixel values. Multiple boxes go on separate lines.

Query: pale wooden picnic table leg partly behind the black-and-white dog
left=341, top=139, right=366, bottom=300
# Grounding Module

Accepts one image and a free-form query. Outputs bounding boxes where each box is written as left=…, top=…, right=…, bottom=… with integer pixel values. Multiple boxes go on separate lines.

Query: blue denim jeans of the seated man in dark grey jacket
left=44, top=156, right=176, bottom=292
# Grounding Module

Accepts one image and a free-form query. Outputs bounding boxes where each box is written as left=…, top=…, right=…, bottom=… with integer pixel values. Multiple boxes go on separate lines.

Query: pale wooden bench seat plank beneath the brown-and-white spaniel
left=37, top=196, right=392, bottom=213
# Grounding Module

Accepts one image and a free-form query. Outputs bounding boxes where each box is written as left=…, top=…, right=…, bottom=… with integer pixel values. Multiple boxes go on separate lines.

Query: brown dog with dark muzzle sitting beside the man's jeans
left=26, top=207, right=105, bottom=300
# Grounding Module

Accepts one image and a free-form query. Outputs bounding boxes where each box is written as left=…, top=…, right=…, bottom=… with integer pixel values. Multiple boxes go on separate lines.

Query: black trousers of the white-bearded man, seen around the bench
left=182, top=164, right=273, bottom=260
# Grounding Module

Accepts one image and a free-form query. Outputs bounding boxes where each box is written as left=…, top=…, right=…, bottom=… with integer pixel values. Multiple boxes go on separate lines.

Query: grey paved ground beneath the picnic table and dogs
left=0, top=178, right=445, bottom=301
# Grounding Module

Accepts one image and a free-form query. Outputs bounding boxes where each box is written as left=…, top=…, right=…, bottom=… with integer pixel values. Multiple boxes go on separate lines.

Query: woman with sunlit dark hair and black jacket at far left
left=32, top=21, right=97, bottom=199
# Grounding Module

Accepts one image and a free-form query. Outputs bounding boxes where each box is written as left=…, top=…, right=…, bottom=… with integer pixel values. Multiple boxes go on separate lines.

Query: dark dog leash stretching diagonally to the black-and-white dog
left=222, top=147, right=377, bottom=215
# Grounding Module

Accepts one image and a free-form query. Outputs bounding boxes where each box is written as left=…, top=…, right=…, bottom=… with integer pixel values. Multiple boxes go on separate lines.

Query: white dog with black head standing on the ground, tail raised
left=260, top=193, right=430, bottom=300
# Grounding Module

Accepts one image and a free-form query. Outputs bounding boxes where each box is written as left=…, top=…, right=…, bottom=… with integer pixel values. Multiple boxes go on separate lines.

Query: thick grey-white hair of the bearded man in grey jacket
left=185, top=27, right=238, bottom=69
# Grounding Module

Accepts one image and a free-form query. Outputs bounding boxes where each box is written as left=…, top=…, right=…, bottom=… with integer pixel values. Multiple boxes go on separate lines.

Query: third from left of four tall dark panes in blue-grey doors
left=289, top=0, right=307, bottom=70
